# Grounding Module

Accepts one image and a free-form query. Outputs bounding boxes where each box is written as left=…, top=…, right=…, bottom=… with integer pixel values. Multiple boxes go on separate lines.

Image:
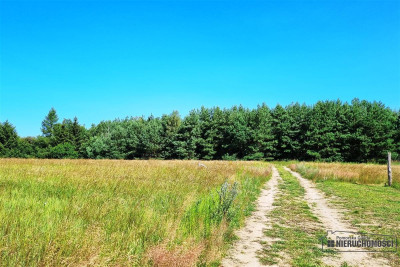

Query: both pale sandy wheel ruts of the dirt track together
left=222, top=167, right=389, bottom=267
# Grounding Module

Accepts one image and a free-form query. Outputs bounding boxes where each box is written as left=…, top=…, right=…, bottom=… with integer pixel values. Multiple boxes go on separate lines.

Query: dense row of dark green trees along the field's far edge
left=0, top=99, right=400, bottom=162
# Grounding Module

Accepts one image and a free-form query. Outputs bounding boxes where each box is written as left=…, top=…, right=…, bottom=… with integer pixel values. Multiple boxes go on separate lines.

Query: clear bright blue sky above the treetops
left=0, top=0, right=400, bottom=136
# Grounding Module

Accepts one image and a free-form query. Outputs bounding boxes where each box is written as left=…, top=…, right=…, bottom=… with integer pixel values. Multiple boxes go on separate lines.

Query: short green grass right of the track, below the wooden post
left=291, top=165, right=400, bottom=266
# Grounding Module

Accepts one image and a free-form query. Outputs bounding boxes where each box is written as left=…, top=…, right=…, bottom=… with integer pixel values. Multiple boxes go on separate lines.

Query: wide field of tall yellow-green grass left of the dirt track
left=0, top=159, right=270, bottom=266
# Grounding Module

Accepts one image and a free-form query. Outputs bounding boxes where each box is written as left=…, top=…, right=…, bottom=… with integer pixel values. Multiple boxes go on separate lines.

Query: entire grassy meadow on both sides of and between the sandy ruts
left=0, top=159, right=400, bottom=266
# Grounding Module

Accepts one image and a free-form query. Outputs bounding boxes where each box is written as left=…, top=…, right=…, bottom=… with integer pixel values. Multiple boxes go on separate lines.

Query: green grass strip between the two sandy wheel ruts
left=261, top=166, right=325, bottom=266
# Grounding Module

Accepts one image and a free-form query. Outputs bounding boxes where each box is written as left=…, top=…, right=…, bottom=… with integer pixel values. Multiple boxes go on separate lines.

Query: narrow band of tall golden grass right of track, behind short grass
left=290, top=162, right=400, bottom=189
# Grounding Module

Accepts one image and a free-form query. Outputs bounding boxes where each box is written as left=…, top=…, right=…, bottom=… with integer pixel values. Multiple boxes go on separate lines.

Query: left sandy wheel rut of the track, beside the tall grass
left=222, top=167, right=281, bottom=267
